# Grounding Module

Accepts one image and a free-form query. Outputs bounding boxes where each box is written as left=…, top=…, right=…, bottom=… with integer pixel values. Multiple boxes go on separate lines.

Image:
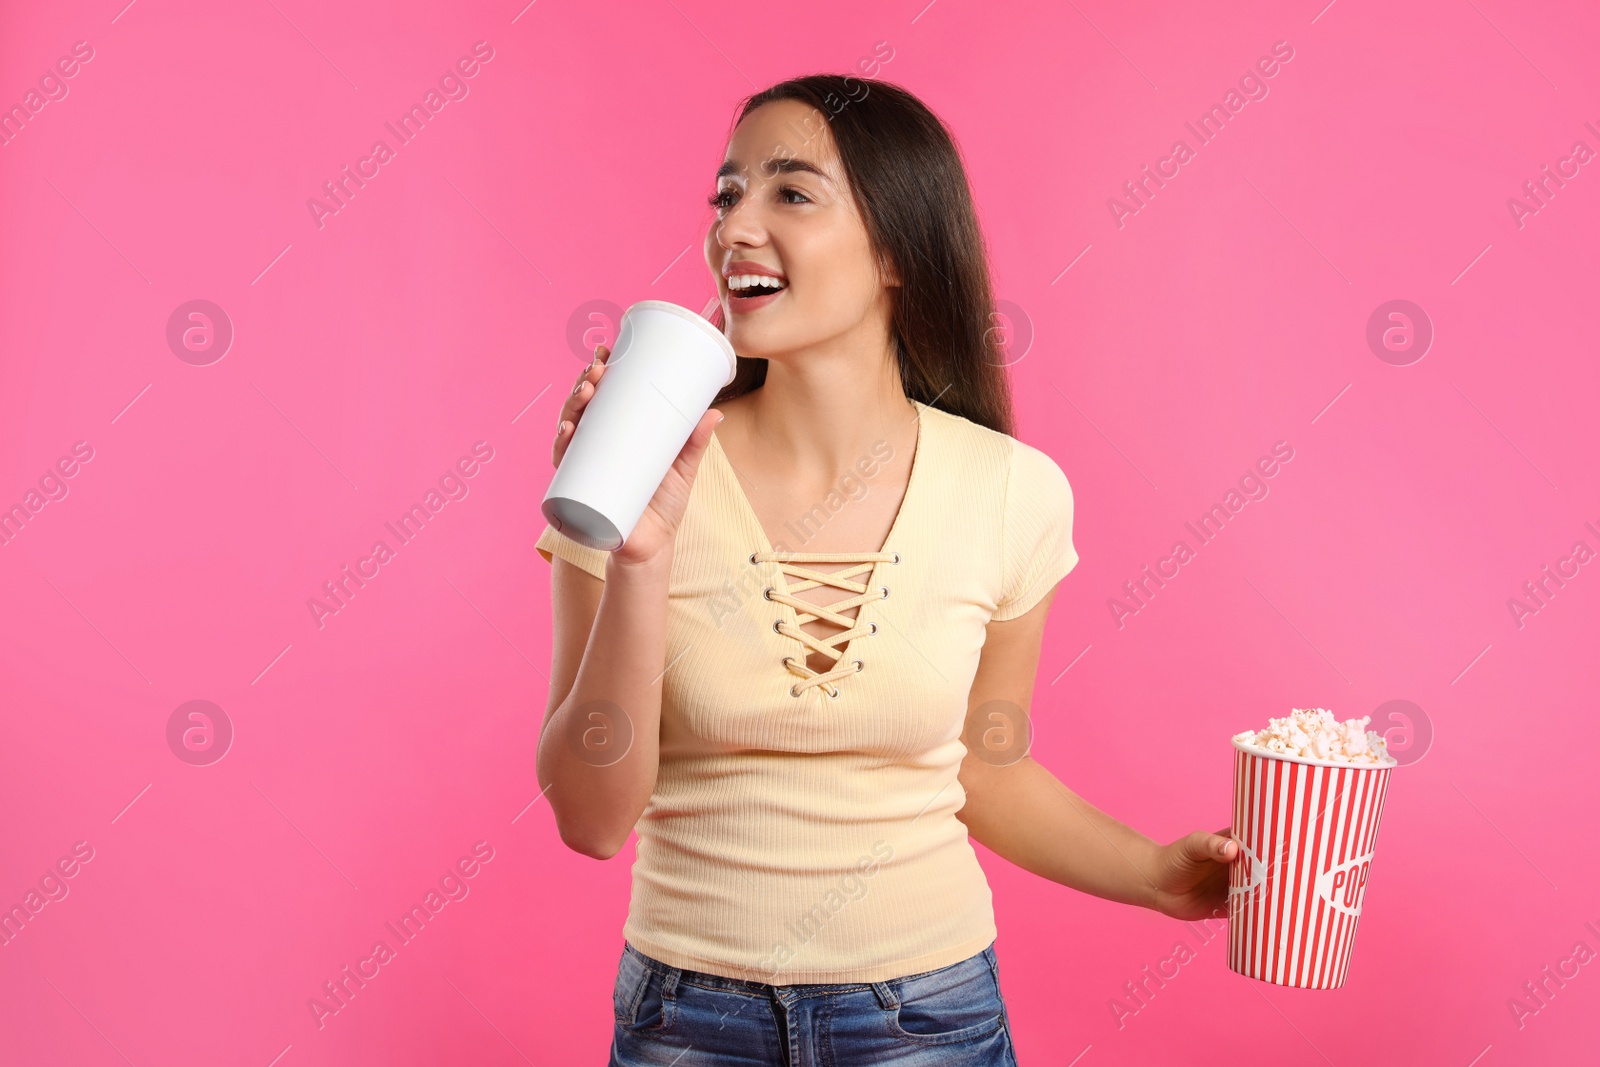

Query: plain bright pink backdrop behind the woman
left=0, top=0, right=1600, bottom=1067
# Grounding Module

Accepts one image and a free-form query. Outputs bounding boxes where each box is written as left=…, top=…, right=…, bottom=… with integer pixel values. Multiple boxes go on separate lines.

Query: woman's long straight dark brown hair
left=710, top=74, right=1013, bottom=435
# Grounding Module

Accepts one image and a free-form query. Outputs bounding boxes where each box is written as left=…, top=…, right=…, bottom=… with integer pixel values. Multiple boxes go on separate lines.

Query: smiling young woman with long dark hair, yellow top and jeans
left=538, top=75, right=1237, bottom=1067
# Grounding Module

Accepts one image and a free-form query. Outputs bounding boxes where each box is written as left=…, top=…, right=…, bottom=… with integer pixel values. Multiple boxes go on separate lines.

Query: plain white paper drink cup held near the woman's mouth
left=539, top=301, right=736, bottom=552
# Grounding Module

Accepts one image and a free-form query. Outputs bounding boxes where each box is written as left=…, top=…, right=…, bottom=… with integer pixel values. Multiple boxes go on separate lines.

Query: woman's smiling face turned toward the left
left=706, top=99, right=894, bottom=358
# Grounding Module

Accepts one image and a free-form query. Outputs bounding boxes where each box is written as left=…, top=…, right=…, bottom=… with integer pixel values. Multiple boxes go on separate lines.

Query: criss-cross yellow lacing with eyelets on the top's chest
left=750, top=552, right=901, bottom=699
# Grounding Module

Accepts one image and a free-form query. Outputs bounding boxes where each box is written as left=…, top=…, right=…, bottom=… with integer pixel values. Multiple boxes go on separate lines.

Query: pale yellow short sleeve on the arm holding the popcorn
left=990, top=438, right=1078, bottom=621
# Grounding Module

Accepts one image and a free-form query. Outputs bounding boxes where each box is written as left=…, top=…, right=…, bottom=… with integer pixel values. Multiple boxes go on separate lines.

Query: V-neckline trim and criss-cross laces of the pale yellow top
left=707, top=400, right=928, bottom=699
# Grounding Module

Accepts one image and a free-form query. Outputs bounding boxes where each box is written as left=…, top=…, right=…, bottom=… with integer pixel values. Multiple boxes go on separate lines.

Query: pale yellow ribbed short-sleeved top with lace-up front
left=536, top=402, right=1078, bottom=985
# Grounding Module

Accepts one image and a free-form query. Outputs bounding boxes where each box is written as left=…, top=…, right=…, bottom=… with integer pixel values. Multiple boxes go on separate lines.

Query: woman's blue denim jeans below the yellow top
left=610, top=942, right=1016, bottom=1067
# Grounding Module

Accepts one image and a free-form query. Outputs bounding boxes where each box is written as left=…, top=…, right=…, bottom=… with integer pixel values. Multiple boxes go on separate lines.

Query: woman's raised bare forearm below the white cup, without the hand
left=536, top=552, right=672, bottom=859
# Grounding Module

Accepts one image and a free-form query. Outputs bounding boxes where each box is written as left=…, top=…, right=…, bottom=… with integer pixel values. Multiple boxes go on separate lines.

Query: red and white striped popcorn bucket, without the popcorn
left=1227, top=741, right=1394, bottom=989
